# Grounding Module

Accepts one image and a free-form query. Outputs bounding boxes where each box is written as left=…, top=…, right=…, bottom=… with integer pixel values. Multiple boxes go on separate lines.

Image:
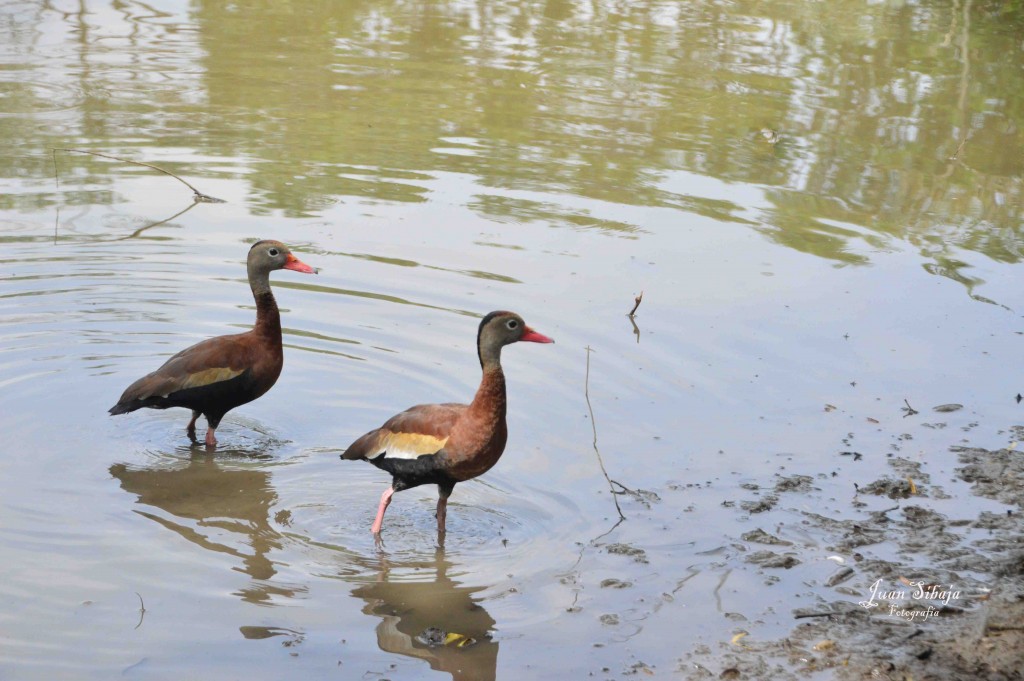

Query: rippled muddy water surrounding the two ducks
left=0, top=1, right=1024, bottom=680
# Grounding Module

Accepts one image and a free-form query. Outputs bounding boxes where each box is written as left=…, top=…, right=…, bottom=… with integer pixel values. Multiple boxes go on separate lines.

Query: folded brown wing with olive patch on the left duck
left=110, top=334, right=258, bottom=414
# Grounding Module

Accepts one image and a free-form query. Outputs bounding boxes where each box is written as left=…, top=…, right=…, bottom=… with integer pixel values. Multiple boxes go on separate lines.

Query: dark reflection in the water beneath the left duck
left=110, top=455, right=307, bottom=605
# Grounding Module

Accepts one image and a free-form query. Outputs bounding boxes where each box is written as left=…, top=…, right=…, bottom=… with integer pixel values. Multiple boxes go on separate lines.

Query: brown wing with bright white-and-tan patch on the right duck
left=341, top=403, right=467, bottom=460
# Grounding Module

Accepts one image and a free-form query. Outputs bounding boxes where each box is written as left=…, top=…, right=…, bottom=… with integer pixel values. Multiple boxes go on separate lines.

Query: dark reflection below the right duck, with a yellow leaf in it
left=352, top=547, right=498, bottom=681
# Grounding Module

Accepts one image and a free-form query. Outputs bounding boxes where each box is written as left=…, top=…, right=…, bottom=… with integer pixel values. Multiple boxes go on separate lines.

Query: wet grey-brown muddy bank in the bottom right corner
left=678, top=444, right=1024, bottom=681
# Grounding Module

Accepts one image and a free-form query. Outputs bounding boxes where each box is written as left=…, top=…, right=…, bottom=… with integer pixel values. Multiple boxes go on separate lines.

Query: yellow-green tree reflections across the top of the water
left=8, top=0, right=1024, bottom=292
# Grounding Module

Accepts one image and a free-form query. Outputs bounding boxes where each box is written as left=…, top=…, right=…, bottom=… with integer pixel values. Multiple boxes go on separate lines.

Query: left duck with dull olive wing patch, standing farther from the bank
left=109, top=240, right=317, bottom=449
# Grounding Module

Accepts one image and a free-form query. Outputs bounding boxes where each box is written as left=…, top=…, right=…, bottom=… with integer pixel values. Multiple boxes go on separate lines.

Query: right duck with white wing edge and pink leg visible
left=341, top=310, right=555, bottom=543
